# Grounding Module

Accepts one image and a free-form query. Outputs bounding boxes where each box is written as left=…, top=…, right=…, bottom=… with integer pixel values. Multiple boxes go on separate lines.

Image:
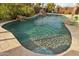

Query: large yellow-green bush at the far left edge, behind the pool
left=0, top=4, right=16, bottom=20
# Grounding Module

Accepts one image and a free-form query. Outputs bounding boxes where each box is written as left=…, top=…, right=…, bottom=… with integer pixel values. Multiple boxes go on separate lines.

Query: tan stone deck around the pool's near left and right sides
left=0, top=14, right=79, bottom=56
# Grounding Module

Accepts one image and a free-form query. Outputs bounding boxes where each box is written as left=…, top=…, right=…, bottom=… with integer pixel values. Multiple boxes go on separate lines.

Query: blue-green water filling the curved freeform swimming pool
left=2, top=15, right=71, bottom=55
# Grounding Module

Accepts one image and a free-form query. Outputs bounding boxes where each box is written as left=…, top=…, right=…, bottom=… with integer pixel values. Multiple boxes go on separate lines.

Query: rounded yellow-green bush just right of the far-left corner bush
left=17, top=6, right=35, bottom=17
